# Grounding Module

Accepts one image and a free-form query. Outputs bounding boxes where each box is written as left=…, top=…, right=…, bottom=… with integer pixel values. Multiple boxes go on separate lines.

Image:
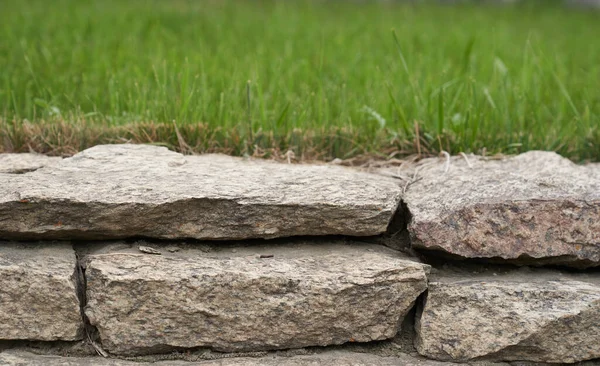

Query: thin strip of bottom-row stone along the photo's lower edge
left=0, top=351, right=504, bottom=366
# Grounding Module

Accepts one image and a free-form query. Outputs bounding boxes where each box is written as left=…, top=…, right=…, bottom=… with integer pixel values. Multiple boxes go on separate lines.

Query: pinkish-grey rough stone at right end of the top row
left=403, top=151, right=600, bottom=267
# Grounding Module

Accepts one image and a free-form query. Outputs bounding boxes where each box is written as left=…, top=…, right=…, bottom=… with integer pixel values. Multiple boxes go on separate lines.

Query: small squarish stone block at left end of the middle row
left=0, top=242, right=83, bottom=341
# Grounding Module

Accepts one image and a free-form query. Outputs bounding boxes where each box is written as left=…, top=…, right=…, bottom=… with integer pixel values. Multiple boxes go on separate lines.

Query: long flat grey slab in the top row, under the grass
left=0, top=145, right=400, bottom=240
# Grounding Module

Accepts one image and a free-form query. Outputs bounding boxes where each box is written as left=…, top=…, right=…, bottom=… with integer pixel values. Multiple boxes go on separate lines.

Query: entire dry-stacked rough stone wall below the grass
left=0, top=145, right=600, bottom=366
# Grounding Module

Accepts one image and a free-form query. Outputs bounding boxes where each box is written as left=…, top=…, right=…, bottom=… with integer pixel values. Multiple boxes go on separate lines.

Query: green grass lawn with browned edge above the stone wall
left=0, top=0, right=600, bottom=161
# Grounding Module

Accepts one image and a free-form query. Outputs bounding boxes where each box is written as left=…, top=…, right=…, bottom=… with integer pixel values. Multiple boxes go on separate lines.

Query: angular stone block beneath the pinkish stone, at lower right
left=415, top=268, right=600, bottom=363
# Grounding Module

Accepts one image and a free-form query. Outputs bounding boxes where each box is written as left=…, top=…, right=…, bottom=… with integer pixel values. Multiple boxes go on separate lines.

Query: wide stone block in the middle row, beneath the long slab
left=84, top=243, right=429, bottom=355
